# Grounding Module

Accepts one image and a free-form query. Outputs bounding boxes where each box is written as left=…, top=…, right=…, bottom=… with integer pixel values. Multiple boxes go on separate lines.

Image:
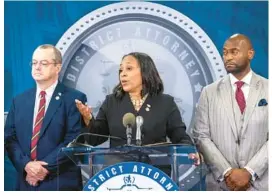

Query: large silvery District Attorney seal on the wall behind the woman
left=57, top=2, right=226, bottom=137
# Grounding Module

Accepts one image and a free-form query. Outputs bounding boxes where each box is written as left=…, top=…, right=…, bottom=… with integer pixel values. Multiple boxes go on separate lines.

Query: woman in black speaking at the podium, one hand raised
left=76, top=52, right=193, bottom=147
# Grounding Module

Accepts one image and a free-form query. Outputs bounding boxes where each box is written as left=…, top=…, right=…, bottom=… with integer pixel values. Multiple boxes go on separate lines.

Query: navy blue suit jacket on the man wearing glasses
left=5, top=83, right=86, bottom=190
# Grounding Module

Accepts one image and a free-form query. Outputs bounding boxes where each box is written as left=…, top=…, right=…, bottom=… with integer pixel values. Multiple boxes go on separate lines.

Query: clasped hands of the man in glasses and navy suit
left=25, top=161, right=49, bottom=186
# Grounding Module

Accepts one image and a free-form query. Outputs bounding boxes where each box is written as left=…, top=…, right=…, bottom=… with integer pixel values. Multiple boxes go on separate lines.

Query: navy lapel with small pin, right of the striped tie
left=40, top=83, right=64, bottom=137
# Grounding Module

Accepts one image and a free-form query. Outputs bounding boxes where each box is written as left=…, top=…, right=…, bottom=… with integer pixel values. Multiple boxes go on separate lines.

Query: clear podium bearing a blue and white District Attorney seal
left=61, top=144, right=206, bottom=191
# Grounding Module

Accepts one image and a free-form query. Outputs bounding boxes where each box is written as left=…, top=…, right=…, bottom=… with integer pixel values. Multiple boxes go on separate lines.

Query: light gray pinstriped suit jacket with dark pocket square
left=193, top=73, right=268, bottom=190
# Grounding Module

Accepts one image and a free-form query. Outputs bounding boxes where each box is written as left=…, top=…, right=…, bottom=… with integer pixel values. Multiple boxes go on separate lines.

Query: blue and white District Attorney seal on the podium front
left=83, top=162, right=179, bottom=191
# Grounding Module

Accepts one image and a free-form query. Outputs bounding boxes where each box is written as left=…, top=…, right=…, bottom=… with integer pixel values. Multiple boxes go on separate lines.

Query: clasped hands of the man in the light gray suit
left=224, top=168, right=251, bottom=191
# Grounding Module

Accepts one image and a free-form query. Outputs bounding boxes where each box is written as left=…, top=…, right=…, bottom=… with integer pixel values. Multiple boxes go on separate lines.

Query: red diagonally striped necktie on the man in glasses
left=31, top=91, right=46, bottom=160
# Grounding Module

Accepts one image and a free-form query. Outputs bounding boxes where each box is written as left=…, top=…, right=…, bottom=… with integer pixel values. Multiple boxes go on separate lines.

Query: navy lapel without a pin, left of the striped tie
left=23, top=88, right=37, bottom=152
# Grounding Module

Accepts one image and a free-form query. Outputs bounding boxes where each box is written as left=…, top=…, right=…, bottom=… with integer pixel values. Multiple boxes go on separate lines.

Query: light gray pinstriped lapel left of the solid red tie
left=219, top=75, right=238, bottom=138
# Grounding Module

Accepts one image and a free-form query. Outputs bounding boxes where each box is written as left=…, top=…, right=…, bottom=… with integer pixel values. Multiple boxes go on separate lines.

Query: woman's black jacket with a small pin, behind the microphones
left=85, top=94, right=192, bottom=147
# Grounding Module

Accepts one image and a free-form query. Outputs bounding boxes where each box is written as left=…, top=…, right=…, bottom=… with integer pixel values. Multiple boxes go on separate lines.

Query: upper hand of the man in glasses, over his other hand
left=25, top=161, right=49, bottom=181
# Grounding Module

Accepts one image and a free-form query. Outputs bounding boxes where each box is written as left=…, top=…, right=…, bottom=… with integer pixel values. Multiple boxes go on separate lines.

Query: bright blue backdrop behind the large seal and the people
left=4, top=1, right=268, bottom=190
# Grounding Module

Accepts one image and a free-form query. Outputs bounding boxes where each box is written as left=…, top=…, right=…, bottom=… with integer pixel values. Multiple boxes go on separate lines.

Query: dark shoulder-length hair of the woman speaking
left=113, top=52, right=164, bottom=99
